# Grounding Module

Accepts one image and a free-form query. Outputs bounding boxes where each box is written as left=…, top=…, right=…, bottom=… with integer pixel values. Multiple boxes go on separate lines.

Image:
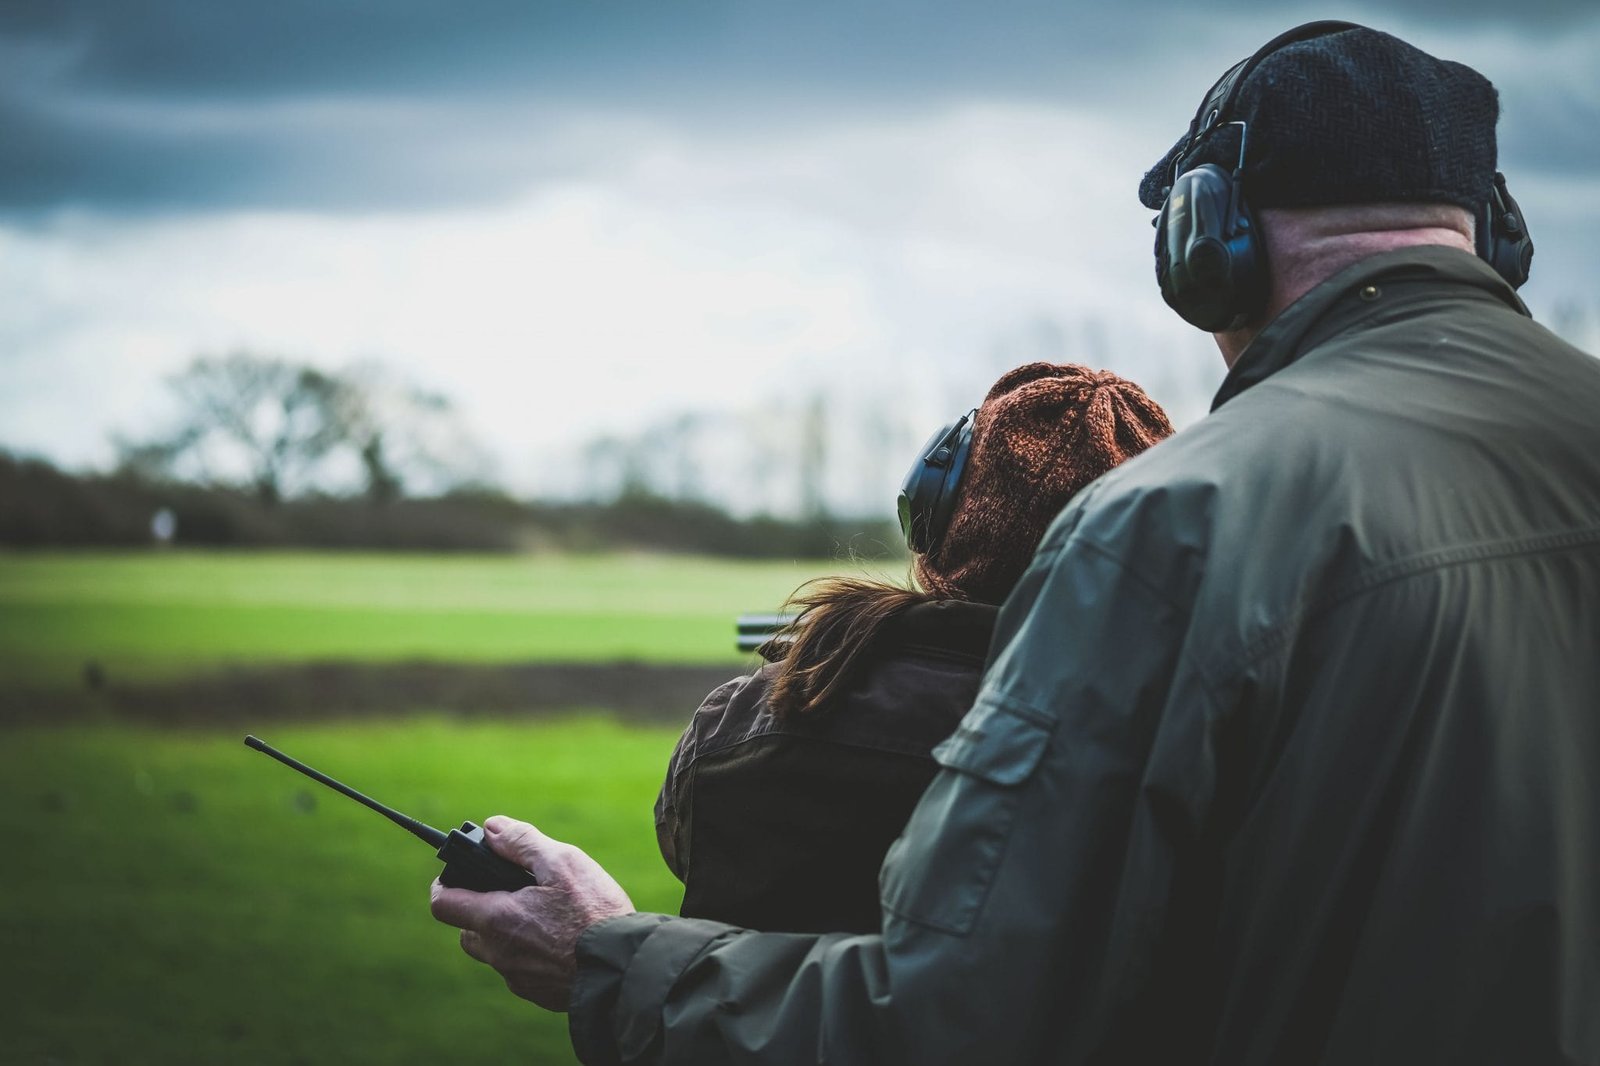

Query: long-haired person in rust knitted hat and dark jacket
left=656, top=363, right=1173, bottom=932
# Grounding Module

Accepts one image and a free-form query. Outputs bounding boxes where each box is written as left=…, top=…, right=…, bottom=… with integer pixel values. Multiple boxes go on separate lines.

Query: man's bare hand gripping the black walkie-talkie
left=432, top=815, right=634, bottom=1010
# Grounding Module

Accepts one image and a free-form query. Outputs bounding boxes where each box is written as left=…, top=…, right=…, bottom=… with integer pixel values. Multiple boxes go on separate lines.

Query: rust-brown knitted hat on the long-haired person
left=915, top=363, right=1173, bottom=603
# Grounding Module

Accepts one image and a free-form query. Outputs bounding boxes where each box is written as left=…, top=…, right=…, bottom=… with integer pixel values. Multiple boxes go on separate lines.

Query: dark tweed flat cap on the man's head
left=1139, top=27, right=1499, bottom=210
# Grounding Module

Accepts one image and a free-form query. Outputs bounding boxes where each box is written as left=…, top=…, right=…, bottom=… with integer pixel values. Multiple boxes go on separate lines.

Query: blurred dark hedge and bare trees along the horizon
left=0, top=344, right=899, bottom=557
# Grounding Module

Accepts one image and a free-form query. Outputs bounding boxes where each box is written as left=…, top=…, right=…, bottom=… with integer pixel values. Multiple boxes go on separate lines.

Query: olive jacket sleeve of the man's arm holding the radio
left=571, top=492, right=1216, bottom=1066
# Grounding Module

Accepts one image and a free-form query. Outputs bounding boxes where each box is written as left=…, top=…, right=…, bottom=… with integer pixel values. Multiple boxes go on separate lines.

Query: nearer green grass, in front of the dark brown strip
left=0, top=713, right=680, bottom=1066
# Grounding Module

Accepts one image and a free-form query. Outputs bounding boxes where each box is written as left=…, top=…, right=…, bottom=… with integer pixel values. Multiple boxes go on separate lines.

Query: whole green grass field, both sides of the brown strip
left=0, top=552, right=902, bottom=1066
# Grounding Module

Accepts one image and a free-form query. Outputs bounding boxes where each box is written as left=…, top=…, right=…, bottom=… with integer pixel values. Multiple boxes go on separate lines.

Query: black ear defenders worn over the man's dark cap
left=1154, top=21, right=1533, bottom=333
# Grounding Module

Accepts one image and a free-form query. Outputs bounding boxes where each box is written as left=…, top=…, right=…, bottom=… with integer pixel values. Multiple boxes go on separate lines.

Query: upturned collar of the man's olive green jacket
left=1211, top=245, right=1528, bottom=411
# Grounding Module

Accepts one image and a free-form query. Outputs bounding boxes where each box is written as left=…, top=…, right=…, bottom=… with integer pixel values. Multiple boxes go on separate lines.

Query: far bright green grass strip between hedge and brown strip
left=0, top=552, right=893, bottom=685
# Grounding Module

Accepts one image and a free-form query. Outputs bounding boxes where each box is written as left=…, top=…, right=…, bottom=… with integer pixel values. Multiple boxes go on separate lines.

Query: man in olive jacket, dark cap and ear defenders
left=434, top=26, right=1600, bottom=1064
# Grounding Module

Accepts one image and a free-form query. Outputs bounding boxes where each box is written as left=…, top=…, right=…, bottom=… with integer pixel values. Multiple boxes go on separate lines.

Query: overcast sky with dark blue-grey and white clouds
left=0, top=0, right=1600, bottom=505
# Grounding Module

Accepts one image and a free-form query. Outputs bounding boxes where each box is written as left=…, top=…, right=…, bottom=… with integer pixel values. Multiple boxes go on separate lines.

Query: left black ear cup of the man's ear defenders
left=1155, top=163, right=1267, bottom=333
